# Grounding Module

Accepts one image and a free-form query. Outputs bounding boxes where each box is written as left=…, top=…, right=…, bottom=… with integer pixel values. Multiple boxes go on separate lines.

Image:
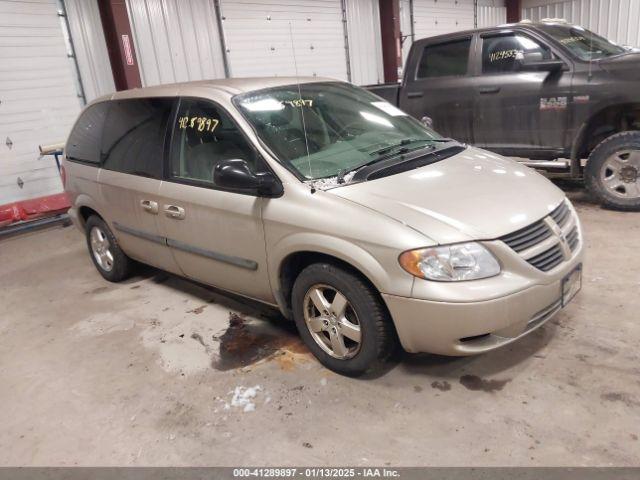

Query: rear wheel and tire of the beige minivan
left=85, top=215, right=133, bottom=282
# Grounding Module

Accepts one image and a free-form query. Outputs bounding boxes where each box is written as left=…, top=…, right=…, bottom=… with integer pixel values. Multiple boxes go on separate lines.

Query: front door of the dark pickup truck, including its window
left=474, top=32, right=571, bottom=158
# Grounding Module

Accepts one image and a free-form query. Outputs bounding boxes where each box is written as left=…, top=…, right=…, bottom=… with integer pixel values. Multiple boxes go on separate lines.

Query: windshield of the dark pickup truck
left=541, top=24, right=626, bottom=62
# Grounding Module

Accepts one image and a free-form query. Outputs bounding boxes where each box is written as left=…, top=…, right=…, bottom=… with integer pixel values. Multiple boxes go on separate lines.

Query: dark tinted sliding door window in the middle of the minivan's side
left=102, top=98, right=173, bottom=178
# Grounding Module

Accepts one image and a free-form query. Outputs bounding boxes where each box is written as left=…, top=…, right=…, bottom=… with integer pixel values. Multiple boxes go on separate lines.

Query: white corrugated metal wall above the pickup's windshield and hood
left=522, top=0, right=640, bottom=47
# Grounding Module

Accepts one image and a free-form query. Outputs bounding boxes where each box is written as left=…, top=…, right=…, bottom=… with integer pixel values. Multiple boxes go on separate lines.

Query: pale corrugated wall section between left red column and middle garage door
left=127, top=0, right=226, bottom=86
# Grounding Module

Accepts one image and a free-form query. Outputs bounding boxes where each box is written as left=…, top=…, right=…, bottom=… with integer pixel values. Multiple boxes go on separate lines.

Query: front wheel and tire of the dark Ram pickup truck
left=585, top=132, right=640, bottom=211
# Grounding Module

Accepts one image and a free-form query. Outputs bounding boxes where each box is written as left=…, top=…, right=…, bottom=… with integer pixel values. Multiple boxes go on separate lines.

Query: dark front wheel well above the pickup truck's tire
left=576, top=103, right=640, bottom=159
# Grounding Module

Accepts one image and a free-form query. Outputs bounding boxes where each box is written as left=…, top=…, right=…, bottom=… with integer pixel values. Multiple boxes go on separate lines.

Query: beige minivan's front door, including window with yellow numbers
left=159, top=98, right=272, bottom=301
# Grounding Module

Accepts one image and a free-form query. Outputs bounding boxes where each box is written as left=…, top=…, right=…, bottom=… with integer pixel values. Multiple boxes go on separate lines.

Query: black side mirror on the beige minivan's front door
left=213, top=158, right=282, bottom=197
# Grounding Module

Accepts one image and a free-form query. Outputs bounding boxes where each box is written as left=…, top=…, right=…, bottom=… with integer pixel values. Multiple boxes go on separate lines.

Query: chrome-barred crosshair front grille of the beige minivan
left=500, top=201, right=580, bottom=272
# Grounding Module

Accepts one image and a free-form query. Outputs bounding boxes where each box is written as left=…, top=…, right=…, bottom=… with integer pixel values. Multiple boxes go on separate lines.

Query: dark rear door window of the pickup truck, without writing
left=418, top=38, right=471, bottom=78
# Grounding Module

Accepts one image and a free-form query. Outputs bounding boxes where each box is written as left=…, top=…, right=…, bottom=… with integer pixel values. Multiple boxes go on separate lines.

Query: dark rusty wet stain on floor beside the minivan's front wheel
left=211, top=312, right=308, bottom=371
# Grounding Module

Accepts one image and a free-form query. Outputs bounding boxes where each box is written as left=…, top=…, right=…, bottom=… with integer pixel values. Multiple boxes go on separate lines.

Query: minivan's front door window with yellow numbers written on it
left=171, top=99, right=257, bottom=184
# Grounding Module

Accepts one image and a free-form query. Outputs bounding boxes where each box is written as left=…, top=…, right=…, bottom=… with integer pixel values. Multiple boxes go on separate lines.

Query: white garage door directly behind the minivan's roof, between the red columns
left=221, top=0, right=347, bottom=80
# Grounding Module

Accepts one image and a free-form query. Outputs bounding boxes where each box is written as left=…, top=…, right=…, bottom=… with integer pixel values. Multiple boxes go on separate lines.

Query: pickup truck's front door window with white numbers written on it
left=482, top=34, right=553, bottom=73
